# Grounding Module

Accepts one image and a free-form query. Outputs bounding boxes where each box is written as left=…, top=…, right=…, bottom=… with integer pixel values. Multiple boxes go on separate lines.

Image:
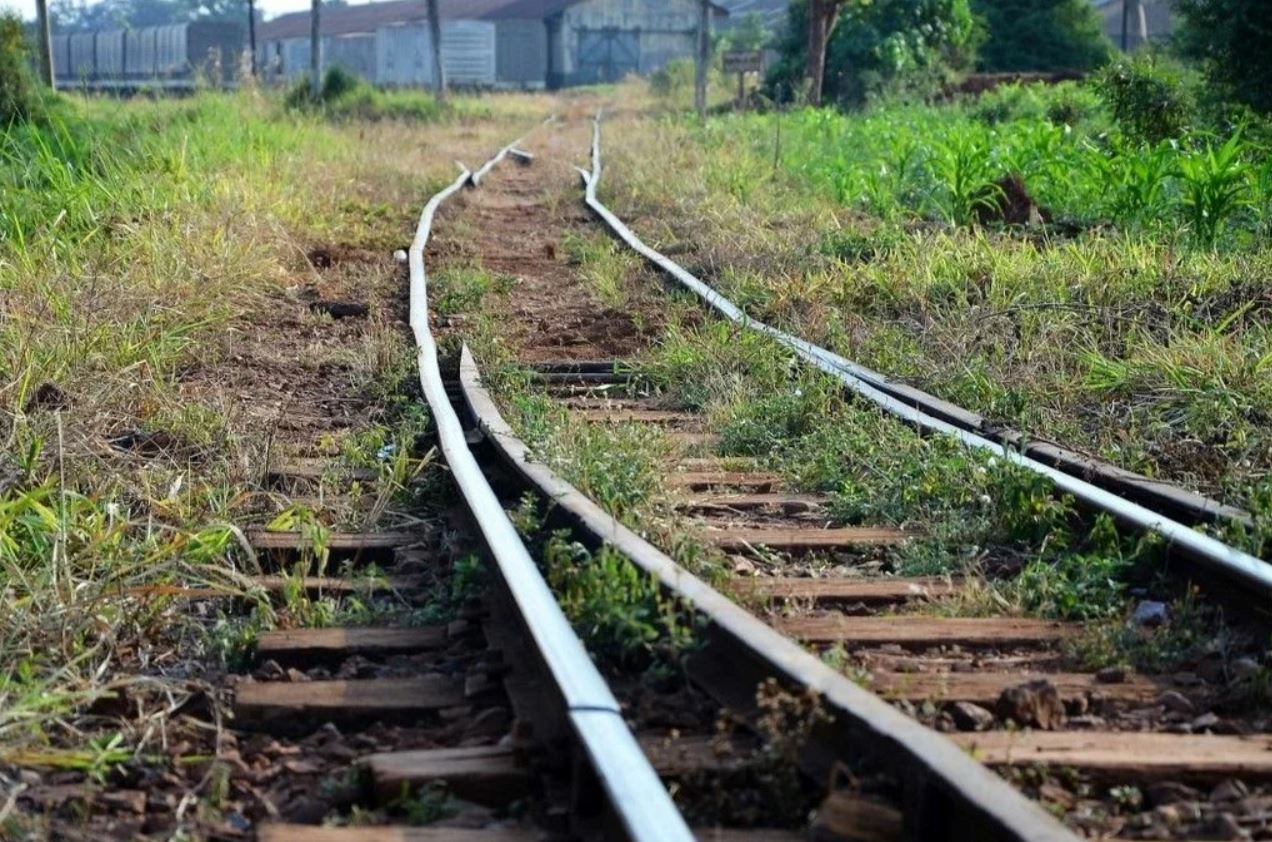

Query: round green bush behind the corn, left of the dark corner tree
left=1095, top=55, right=1197, bottom=144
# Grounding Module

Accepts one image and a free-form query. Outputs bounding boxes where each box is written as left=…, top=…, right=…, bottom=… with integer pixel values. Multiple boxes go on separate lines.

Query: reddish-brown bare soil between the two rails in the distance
left=431, top=120, right=663, bottom=361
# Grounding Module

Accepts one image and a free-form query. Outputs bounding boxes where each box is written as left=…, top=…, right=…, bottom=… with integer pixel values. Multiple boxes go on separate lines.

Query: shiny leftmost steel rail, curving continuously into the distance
left=407, top=149, right=693, bottom=842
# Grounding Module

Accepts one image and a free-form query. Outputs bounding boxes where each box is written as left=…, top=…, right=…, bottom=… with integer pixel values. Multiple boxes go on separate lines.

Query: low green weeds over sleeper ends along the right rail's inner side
left=640, top=315, right=1241, bottom=670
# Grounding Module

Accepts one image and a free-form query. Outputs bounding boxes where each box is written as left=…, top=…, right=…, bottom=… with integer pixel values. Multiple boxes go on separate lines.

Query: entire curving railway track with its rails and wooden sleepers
left=39, top=105, right=1272, bottom=842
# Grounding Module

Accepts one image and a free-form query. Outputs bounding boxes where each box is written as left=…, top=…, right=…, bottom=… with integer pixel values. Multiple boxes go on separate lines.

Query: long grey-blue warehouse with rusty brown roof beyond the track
left=258, top=0, right=728, bottom=88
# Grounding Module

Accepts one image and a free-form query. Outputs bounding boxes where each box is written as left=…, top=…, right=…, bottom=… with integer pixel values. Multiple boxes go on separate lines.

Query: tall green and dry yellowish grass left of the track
left=0, top=83, right=542, bottom=836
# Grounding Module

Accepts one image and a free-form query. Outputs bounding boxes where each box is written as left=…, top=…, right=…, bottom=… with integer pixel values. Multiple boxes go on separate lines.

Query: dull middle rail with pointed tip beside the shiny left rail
left=459, top=346, right=1075, bottom=842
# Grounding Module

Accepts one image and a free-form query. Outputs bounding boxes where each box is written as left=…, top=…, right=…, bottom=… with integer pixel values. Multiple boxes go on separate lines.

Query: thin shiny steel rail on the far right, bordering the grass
left=579, top=114, right=1272, bottom=595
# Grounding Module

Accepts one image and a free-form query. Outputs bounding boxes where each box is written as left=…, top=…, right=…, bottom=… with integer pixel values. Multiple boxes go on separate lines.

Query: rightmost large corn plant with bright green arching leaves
left=1178, top=135, right=1250, bottom=247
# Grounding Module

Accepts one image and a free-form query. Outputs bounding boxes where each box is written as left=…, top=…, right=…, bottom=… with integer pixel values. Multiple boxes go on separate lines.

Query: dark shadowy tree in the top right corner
left=1175, top=0, right=1272, bottom=113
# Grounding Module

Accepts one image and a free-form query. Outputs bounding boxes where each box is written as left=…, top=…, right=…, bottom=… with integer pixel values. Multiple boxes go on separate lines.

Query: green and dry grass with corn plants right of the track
left=602, top=77, right=1272, bottom=534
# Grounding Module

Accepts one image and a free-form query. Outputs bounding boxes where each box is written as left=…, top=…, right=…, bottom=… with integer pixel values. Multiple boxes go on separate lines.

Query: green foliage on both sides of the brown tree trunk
left=767, top=0, right=979, bottom=104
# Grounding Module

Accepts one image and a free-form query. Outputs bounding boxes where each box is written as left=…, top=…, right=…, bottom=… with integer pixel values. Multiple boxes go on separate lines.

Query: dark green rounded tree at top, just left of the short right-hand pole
left=972, top=0, right=1113, bottom=72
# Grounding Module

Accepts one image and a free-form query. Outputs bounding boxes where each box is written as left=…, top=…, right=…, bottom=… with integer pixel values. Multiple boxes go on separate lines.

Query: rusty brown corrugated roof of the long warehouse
left=259, top=0, right=726, bottom=41
